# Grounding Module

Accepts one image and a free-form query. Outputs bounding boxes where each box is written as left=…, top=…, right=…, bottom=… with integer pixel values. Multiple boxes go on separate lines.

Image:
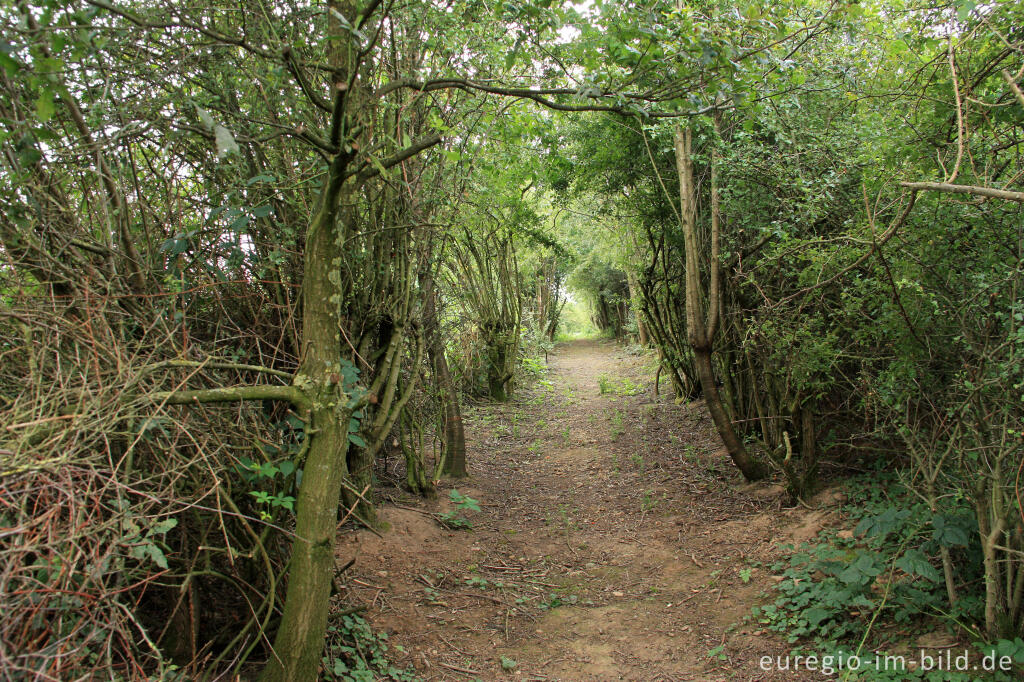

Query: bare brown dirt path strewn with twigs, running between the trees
left=337, top=341, right=842, bottom=682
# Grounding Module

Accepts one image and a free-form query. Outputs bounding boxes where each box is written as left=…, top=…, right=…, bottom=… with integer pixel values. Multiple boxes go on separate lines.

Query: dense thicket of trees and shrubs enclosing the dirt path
left=0, top=0, right=1024, bottom=680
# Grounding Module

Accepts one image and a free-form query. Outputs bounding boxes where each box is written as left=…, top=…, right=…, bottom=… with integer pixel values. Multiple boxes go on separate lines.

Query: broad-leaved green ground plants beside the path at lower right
left=753, top=473, right=1017, bottom=680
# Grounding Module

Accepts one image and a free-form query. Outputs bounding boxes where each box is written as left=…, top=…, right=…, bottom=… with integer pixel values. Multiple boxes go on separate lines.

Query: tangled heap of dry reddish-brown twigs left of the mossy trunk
left=0, top=296, right=301, bottom=680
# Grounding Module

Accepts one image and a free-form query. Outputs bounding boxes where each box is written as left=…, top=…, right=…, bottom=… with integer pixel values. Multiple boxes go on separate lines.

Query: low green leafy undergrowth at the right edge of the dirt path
left=752, top=473, right=1024, bottom=681
